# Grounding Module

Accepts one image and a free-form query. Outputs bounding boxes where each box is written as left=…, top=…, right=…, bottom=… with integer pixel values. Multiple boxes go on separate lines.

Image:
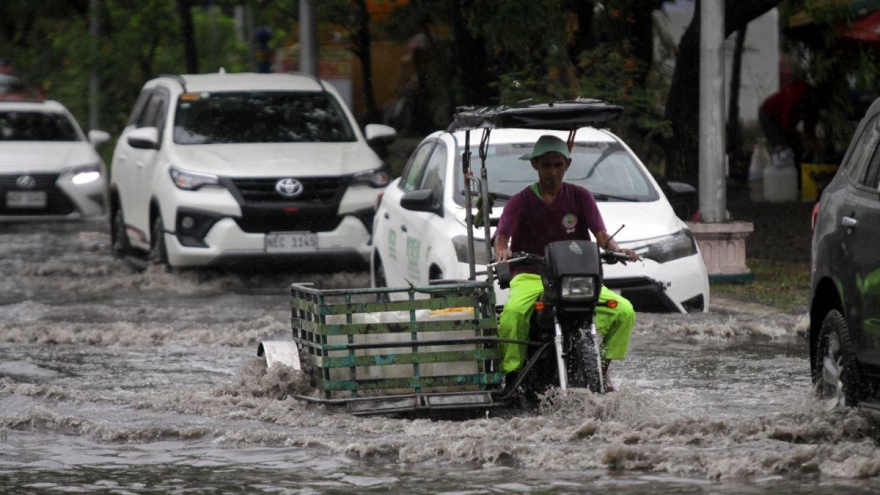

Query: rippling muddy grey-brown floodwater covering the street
left=0, top=222, right=880, bottom=495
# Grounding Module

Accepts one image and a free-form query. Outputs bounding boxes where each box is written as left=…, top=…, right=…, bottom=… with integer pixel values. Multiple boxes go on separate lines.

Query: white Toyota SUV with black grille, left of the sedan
left=110, top=73, right=396, bottom=267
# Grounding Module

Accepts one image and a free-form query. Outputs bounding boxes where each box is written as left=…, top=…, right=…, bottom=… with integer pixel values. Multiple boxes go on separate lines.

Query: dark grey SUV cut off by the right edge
left=810, top=99, right=880, bottom=409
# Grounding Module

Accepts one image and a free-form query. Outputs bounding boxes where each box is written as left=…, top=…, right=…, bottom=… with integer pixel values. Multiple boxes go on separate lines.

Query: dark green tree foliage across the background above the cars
left=0, top=0, right=878, bottom=184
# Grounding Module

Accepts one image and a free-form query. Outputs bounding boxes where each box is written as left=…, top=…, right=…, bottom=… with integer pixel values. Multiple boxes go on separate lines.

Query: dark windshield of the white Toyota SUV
left=174, top=91, right=355, bottom=144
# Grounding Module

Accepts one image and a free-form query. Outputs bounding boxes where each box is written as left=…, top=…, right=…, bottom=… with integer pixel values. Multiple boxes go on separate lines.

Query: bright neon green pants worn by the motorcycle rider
left=498, top=273, right=636, bottom=374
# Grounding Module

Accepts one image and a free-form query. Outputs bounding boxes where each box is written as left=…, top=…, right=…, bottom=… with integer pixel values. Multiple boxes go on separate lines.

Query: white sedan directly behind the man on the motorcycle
left=371, top=127, right=709, bottom=312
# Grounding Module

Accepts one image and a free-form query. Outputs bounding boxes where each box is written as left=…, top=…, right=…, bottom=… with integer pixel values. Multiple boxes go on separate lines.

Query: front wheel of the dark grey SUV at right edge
left=814, top=310, right=862, bottom=410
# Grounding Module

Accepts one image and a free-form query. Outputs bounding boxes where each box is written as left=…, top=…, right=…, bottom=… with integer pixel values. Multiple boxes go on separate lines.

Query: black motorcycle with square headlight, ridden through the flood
left=492, top=240, right=627, bottom=403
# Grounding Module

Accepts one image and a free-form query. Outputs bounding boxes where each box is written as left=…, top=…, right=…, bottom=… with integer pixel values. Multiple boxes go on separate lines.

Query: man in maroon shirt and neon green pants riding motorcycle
left=493, top=135, right=641, bottom=392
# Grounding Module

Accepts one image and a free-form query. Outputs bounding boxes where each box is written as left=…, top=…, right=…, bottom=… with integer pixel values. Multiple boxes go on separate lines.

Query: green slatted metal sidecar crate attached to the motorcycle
left=291, top=282, right=501, bottom=409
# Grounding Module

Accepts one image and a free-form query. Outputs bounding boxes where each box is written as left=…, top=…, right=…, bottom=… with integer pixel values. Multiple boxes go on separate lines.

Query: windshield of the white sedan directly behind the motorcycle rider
left=455, top=143, right=660, bottom=205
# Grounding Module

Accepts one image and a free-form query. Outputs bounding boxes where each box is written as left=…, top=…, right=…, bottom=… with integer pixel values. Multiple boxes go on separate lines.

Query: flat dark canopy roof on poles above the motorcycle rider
left=448, top=98, right=623, bottom=132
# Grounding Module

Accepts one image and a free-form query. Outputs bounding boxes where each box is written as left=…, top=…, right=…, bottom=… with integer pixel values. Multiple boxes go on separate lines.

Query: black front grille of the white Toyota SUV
left=223, top=177, right=349, bottom=233
